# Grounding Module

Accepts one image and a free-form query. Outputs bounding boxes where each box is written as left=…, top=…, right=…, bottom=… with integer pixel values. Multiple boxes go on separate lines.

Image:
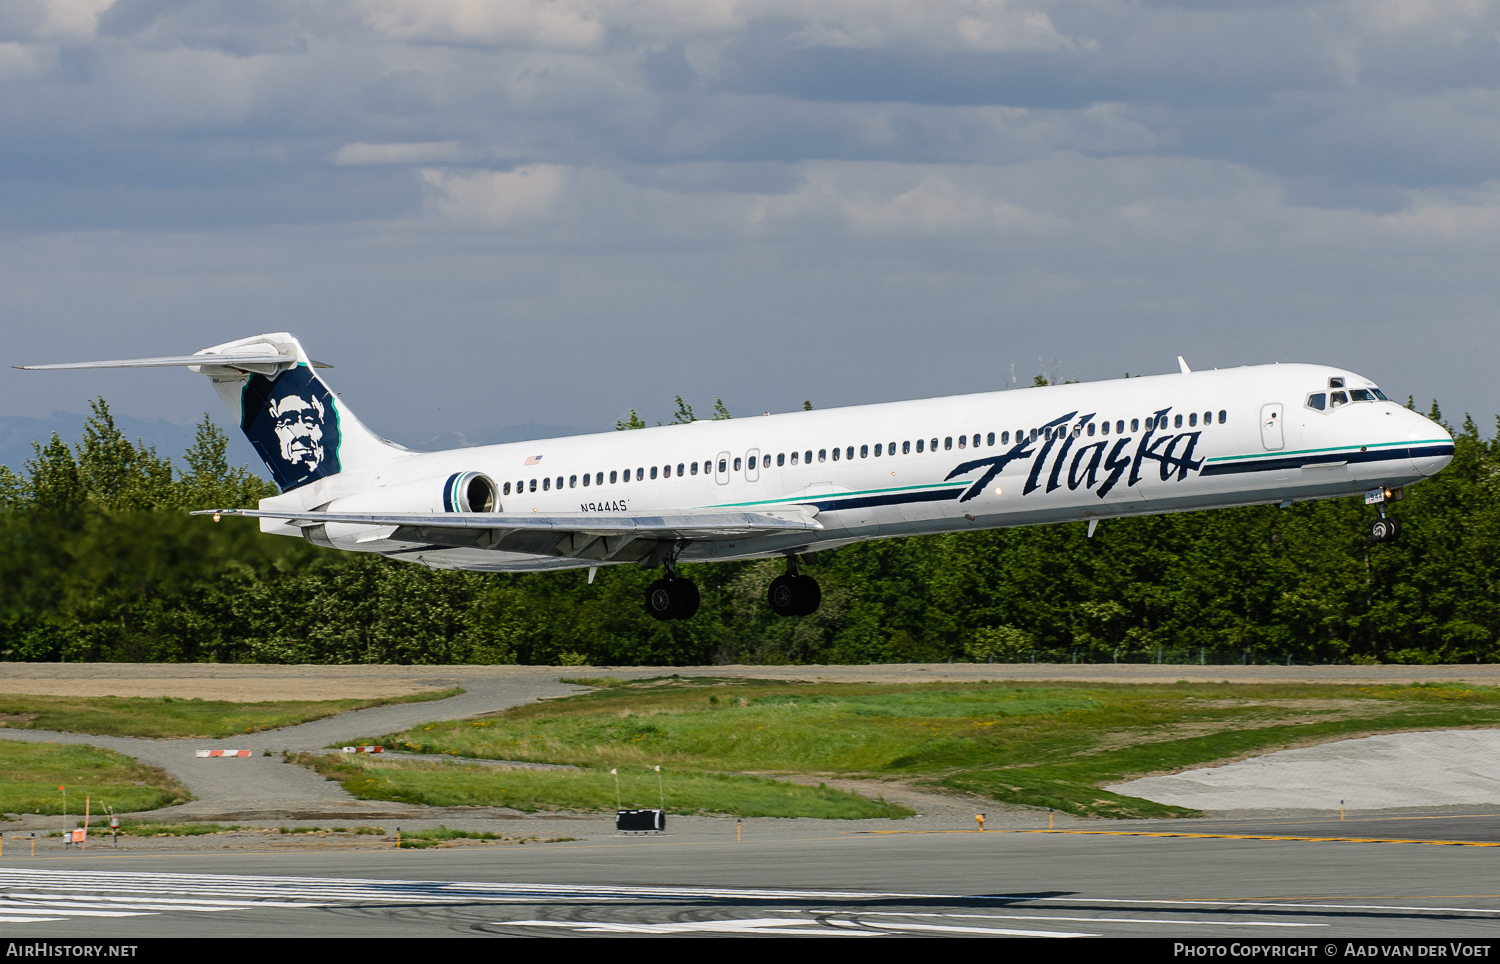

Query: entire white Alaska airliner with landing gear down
left=23, top=333, right=1454, bottom=619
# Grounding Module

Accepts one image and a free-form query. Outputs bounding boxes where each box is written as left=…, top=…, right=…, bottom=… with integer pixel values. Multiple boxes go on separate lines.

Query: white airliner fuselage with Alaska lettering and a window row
left=261, top=364, right=1454, bottom=571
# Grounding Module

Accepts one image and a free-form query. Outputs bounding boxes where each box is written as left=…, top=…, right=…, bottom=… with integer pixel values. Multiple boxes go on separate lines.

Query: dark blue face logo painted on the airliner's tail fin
left=240, top=364, right=339, bottom=492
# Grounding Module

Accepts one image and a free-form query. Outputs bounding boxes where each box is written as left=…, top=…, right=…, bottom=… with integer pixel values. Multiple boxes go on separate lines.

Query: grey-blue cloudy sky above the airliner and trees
left=0, top=0, right=1500, bottom=452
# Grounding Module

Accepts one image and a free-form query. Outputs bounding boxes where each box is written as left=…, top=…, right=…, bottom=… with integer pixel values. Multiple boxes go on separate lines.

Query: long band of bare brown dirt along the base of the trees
left=0, top=663, right=1500, bottom=703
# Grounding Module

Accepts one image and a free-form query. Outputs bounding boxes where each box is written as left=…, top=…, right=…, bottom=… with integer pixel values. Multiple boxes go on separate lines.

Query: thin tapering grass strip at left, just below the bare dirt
left=0, top=688, right=464, bottom=739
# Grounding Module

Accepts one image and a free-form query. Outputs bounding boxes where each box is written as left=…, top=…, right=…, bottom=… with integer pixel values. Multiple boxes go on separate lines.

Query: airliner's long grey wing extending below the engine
left=192, top=507, right=824, bottom=561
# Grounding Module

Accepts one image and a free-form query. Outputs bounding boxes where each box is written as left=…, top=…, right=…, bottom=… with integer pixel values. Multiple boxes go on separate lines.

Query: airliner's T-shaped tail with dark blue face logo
left=17, top=331, right=407, bottom=492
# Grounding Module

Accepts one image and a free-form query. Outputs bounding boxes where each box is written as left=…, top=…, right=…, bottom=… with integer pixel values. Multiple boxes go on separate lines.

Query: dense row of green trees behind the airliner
left=0, top=400, right=1500, bottom=664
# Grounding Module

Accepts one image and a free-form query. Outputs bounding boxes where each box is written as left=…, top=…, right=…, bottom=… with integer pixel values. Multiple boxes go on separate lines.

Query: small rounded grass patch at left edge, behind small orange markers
left=0, top=739, right=194, bottom=816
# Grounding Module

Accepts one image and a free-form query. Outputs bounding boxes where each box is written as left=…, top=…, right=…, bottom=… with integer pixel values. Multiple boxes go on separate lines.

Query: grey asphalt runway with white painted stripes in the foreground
left=0, top=814, right=1500, bottom=942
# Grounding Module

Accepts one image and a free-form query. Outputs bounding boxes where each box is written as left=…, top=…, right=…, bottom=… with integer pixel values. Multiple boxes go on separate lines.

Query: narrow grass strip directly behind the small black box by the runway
left=293, top=754, right=912, bottom=820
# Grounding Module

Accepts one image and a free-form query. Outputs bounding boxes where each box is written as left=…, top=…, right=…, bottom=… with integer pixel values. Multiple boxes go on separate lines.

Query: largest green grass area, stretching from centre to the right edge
left=354, top=676, right=1500, bottom=817
